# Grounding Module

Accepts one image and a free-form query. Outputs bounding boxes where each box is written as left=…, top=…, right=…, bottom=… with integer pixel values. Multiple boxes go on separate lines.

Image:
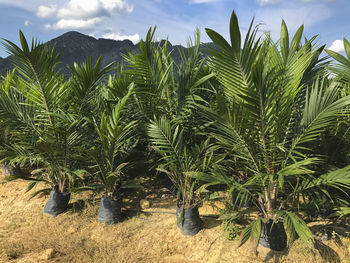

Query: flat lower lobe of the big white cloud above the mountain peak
left=45, top=17, right=102, bottom=30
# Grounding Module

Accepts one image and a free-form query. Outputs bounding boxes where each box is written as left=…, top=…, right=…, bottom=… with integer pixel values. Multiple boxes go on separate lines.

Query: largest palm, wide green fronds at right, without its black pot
left=193, top=12, right=350, bottom=252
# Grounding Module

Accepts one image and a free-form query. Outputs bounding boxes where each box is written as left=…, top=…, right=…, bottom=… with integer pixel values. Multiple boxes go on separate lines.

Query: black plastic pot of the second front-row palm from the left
left=98, top=197, right=122, bottom=225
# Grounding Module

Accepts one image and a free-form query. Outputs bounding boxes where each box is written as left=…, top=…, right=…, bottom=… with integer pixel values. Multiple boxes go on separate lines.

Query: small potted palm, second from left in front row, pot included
left=83, top=84, right=140, bottom=224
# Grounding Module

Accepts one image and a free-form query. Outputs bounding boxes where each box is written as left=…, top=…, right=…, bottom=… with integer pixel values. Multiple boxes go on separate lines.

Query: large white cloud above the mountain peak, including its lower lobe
left=37, top=0, right=133, bottom=30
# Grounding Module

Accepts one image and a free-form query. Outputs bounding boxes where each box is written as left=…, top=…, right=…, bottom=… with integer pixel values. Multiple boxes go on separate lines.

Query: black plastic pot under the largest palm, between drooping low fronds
left=259, top=219, right=287, bottom=251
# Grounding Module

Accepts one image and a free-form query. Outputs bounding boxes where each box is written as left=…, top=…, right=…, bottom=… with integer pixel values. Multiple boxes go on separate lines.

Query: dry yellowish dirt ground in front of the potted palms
left=0, top=172, right=350, bottom=263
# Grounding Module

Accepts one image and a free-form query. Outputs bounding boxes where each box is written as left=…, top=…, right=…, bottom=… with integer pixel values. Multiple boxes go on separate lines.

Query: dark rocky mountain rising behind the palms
left=0, top=31, right=208, bottom=74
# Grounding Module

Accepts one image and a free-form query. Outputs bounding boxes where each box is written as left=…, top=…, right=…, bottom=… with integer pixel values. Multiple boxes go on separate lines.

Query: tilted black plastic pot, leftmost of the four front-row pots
left=44, top=190, right=70, bottom=217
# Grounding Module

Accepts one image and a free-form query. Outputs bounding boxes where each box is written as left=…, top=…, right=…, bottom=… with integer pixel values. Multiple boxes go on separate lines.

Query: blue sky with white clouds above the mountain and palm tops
left=0, top=0, right=350, bottom=57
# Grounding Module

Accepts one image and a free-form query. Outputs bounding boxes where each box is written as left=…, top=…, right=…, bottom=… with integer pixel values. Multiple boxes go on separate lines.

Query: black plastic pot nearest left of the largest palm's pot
left=176, top=205, right=201, bottom=236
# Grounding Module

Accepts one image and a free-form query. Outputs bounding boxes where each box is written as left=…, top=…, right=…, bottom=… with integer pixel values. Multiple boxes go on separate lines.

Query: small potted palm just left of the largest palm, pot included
left=148, top=117, right=216, bottom=236
